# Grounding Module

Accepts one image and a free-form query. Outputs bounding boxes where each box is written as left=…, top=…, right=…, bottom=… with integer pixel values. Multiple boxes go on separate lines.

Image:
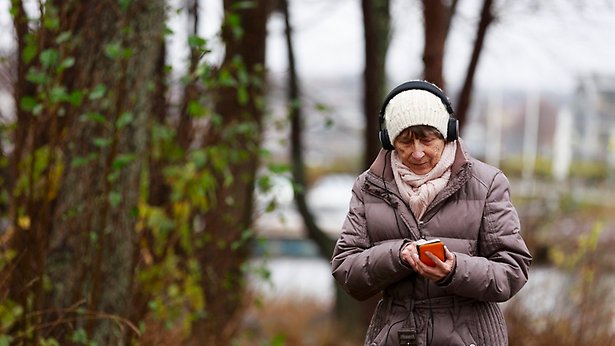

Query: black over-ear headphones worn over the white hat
left=378, top=80, right=459, bottom=150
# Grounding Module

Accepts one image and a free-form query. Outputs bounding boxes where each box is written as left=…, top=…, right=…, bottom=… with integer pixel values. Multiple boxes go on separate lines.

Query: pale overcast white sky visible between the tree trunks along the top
left=0, top=0, right=615, bottom=92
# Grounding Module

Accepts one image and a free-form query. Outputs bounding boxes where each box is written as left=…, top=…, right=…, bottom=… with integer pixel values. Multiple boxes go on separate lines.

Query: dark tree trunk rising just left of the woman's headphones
left=361, top=0, right=391, bottom=168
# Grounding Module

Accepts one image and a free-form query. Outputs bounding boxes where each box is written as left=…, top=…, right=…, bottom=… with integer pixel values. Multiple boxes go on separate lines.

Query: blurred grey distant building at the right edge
left=573, top=75, right=615, bottom=163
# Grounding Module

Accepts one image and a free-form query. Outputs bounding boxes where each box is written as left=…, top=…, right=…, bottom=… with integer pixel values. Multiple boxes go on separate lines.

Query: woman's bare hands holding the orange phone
left=399, top=242, right=457, bottom=281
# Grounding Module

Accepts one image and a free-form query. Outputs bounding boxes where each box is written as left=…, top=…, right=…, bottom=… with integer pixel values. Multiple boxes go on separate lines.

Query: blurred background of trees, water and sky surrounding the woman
left=0, top=0, right=615, bottom=345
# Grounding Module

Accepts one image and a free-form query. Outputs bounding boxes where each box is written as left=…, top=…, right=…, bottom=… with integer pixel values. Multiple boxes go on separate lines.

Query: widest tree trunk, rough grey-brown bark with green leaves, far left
left=7, top=0, right=165, bottom=345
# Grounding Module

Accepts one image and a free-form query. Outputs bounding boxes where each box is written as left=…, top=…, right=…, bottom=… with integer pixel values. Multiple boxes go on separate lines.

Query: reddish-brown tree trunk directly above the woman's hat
left=423, top=0, right=448, bottom=90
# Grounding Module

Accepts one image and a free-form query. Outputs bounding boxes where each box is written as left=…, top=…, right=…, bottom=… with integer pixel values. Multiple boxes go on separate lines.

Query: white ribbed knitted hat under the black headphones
left=384, top=89, right=450, bottom=143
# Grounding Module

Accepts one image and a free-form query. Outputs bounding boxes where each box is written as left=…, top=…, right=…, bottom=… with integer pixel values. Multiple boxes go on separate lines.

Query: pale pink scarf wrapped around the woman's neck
left=391, top=142, right=457, bottom=220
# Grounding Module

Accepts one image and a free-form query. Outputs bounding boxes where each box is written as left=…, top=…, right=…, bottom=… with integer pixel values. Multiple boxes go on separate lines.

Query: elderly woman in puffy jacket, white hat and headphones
left=332, top=81, right=531, bottom=346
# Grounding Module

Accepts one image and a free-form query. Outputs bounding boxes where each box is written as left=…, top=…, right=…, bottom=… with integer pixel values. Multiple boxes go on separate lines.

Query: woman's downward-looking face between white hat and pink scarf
left=393, top=126, right=445, bottom=175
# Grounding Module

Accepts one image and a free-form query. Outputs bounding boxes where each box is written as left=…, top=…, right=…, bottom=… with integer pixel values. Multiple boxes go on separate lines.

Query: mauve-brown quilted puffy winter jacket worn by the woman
left=332, top=141, right=532, bottom=346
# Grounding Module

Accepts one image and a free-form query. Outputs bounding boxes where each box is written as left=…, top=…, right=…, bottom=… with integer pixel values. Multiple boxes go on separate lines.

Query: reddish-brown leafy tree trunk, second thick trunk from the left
left=188, top=0, right=269, bottom=345
